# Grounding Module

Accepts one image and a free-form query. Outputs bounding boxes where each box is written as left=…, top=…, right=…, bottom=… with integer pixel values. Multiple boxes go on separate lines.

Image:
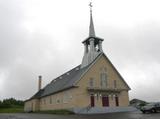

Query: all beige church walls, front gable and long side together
left=25, top=56, right=129, bottom=111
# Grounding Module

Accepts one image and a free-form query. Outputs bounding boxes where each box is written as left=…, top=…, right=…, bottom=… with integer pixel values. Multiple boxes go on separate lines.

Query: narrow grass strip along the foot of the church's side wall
left=34, top=109, right=74, bottom=115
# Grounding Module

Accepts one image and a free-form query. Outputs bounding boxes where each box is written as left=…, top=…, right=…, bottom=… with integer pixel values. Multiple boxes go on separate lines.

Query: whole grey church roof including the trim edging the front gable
left=26, top=53, right=130, bottom=101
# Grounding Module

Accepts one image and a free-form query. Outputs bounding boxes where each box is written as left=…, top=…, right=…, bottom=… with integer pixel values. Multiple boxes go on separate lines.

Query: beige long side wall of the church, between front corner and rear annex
left=40, top=88, right=77, bottom=110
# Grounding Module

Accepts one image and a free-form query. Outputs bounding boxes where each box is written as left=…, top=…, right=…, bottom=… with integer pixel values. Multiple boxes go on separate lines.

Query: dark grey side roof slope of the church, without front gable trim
left=29, top=65, right=89, bottom=100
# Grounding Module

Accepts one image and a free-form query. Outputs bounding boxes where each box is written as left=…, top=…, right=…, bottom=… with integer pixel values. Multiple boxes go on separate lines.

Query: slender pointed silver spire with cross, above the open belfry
left=89, top=2, right=95, bottom=37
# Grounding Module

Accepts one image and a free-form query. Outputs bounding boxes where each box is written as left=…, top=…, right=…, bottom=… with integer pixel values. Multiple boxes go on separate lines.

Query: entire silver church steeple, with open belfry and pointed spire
left=81, top=2, right=103, bottom=68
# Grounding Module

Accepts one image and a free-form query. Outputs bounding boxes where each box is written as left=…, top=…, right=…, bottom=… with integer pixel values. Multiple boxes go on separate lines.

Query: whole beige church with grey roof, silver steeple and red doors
left=24, top=5, right=130, bottom=113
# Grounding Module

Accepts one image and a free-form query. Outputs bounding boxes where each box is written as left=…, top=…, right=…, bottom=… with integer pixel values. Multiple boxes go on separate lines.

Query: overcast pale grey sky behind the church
left=0, top=0, right=160, bottom=101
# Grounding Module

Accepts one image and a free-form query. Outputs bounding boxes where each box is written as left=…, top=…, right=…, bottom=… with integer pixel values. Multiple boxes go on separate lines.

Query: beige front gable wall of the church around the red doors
left=75, top=56, right=129, bottom=107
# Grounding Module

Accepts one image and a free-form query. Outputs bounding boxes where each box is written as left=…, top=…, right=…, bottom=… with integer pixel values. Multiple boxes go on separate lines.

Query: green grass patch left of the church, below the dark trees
left=0, top=107, right=24, bottom=113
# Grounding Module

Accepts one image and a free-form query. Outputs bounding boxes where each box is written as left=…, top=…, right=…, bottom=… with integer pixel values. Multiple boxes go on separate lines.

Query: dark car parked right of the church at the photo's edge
left=140, top=103, right=160, bottom=113
